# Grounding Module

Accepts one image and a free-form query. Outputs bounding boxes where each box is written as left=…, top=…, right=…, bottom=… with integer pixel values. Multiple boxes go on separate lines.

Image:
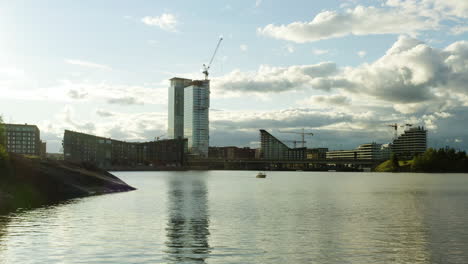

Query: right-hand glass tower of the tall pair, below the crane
left=184, top=80, right=210, bottom=157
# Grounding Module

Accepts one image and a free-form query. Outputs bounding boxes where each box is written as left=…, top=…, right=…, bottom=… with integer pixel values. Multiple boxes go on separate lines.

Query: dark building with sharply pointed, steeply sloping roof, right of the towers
left=260, top=129, right=306, bottom=160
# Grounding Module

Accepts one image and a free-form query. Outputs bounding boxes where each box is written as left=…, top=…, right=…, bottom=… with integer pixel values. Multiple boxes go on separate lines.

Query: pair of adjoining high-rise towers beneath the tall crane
left=168, top=78, right=210, bottom=157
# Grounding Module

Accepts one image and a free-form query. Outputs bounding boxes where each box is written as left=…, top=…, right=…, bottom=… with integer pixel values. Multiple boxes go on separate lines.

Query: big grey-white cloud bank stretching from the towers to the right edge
left=213, top=36, right=468, bottom=113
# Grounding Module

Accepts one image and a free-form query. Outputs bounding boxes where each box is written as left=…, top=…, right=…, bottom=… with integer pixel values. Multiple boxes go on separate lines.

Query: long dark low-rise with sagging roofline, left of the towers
left=63, top=130, right=187, bottom=168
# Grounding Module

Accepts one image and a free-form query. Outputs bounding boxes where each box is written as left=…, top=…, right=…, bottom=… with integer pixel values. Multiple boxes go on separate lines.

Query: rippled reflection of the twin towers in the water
left=166, top=176, right=210, bottom=263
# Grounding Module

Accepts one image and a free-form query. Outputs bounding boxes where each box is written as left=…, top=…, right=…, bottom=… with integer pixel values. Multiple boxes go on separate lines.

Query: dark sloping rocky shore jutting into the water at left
left=0, top=154, right=135, bottom=212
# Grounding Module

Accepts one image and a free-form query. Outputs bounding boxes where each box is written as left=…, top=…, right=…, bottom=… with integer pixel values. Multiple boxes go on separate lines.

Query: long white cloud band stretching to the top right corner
left=257, top=0, right=468, bottom=43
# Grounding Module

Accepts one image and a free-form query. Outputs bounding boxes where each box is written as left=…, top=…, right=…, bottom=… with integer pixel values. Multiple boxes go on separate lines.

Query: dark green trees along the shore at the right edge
left=411, top=148, right=468, bottom=172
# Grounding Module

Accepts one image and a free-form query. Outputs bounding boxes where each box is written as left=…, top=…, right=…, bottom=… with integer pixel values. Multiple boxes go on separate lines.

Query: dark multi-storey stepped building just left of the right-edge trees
left=392, top=127, right=427, bottom=159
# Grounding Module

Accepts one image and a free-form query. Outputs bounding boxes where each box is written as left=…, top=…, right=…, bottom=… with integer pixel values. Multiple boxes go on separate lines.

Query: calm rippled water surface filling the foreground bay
left=0, top=171, right=468, bottom=264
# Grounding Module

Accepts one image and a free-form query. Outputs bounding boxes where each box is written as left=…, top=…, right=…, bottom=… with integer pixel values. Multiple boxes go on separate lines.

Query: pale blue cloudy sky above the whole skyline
left=0, top=0, right=468, bottom=152
